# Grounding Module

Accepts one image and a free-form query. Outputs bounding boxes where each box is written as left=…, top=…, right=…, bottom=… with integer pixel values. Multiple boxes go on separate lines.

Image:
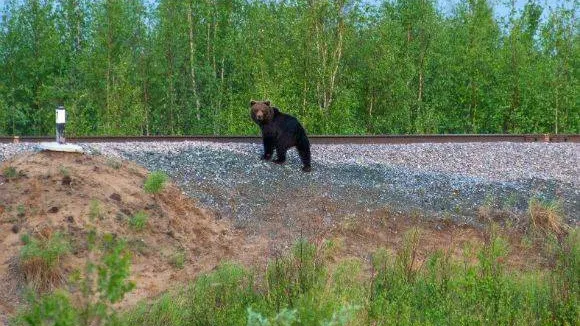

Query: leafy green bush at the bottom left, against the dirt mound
left=12, top=230, right=135, bottom=325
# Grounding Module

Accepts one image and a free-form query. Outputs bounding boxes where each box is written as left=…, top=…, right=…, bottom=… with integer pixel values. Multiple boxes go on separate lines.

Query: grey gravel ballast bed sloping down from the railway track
left=0, top=142, right=580, bottom=227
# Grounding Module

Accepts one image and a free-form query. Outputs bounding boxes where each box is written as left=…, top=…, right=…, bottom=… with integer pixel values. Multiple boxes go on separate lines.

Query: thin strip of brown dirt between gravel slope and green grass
left=259, top=199, right=552, bottom=270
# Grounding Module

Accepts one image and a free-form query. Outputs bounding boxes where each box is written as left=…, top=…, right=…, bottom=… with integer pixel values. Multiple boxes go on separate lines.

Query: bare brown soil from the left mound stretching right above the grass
left=0, top=152, right=542, bottom=322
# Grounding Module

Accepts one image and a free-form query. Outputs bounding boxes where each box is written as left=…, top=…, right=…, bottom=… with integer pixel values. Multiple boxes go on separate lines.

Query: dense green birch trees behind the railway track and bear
left=0, top=0, right=580, bottom=135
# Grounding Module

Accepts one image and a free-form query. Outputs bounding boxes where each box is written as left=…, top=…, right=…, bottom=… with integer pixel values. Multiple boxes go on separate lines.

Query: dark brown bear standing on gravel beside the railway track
left=250, top=101, right=312, bottom=172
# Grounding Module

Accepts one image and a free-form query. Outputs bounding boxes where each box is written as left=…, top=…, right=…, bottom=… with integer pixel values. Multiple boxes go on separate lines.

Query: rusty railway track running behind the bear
left=0, top=134, right=580, bottom=144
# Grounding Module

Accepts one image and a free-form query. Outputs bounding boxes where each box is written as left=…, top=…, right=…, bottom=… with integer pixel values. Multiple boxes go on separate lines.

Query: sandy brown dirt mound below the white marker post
left=0, top=152, right=251, bottom=314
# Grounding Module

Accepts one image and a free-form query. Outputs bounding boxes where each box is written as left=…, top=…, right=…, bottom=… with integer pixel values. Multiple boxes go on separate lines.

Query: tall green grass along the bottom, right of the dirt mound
left=11, top=230, right=580, bottom=325
